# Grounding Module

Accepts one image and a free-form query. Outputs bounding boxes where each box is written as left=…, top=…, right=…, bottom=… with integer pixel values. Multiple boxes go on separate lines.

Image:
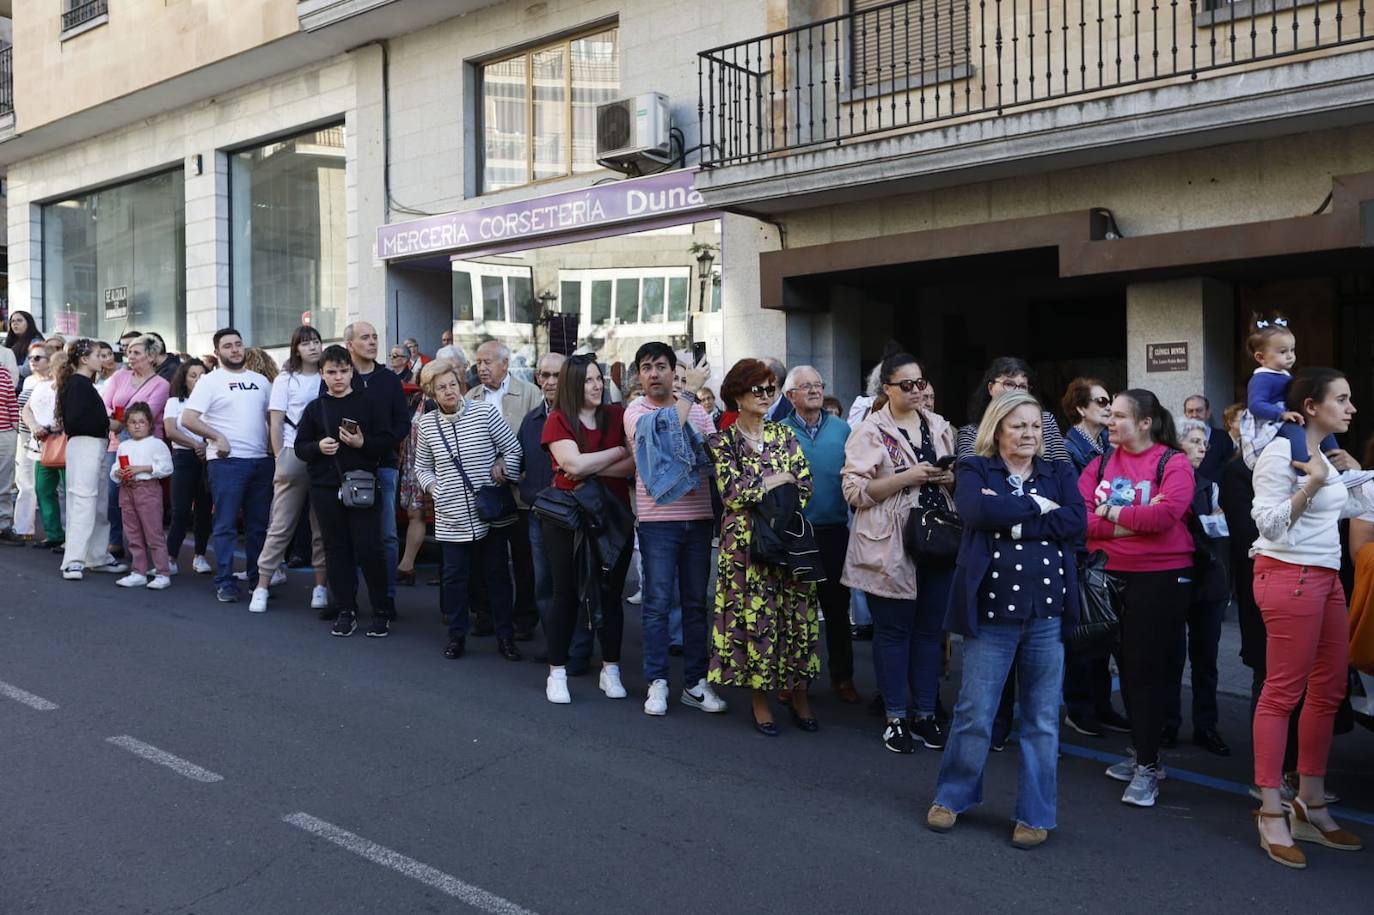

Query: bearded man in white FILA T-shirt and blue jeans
left=181, top=327, right=275, bottom=603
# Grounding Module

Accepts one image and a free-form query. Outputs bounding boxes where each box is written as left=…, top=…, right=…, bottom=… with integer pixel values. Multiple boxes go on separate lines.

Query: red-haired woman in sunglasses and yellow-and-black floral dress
left=706, top=359, right=820, bottom=736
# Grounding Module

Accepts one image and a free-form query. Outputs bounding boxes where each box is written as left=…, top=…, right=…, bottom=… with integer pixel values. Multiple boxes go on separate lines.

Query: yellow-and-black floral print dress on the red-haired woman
left=708, top=422, right=820, bottom=690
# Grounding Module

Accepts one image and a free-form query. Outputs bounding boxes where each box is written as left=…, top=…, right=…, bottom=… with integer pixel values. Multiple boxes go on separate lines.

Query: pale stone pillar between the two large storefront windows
left=185, top=150, right=229, bottom=353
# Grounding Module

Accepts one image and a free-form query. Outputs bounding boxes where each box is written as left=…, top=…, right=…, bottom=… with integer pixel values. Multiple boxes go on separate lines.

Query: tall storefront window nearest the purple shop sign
left=229, top=125, right=348, bottom=346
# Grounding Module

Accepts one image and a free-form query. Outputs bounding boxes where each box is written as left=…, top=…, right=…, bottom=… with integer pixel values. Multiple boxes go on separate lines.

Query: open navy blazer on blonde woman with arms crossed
left=944, top=456, right=1088, bottom=639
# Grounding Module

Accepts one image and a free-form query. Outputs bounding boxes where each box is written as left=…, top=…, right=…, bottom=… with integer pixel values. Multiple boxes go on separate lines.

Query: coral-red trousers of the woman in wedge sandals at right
left=1254, top=556, right=1349, bottom=789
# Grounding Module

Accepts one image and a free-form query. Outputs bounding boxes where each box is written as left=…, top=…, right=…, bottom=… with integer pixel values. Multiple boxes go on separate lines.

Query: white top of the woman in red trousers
left=1250, top=437, right=1374, bottom=570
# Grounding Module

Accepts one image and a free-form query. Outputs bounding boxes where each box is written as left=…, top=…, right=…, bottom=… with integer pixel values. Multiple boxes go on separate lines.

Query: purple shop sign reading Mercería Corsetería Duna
left=376, top=169, right=706, bottom=260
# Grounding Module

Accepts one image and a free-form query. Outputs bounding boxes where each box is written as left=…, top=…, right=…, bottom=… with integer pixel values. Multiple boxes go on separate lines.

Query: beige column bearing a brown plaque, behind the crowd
left=1125, top=276, right=1237, bottom=422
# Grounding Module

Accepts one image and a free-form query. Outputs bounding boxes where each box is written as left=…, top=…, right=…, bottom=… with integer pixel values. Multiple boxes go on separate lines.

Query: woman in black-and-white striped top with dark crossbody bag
left=415, top=359, right=522, bottom=661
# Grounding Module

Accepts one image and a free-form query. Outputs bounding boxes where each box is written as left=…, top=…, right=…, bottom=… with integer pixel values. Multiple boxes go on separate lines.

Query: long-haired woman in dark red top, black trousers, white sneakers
left=536, top=356, right=635, bottom=705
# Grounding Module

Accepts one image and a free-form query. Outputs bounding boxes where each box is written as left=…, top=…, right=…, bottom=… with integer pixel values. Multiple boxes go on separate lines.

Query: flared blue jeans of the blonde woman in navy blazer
left=936, top=618, right=1063, bottom=830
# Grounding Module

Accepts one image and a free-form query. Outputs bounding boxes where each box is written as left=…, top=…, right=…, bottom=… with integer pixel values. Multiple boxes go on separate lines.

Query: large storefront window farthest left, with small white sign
left=43, top=170, right=185, bottom=349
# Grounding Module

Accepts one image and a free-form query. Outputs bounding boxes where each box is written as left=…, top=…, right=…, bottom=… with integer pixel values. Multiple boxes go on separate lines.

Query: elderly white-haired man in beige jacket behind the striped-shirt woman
left=467, top=339, right=544, bottom=642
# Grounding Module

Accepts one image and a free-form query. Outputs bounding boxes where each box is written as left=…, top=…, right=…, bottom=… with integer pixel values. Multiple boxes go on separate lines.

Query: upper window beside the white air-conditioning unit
left=480, top=29, right=620, bottom=191
